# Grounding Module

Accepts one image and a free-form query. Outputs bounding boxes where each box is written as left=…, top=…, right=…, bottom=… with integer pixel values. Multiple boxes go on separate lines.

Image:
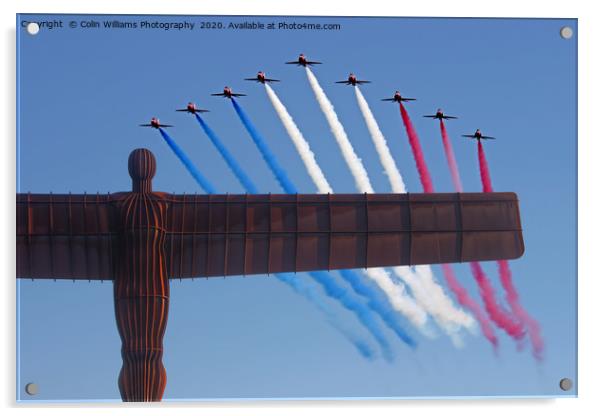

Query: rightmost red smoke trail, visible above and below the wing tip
left=478, top=140, right=544, bottom=360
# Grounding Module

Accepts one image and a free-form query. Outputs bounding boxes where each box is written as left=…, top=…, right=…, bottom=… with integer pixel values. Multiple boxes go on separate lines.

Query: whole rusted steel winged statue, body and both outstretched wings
left=12, top=149, right=524, bottom=401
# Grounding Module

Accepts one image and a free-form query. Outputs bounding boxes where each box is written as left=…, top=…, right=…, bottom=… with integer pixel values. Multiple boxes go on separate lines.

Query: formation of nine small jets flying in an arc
left=140, top=53, right=495, bottom=142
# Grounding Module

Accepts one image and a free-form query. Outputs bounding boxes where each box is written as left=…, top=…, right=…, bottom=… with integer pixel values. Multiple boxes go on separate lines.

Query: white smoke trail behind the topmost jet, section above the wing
left=305, top=66, right=374, bottom=194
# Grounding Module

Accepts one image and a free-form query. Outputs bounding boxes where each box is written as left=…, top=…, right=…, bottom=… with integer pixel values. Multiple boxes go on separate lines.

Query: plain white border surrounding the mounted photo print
left=0, top=0, right=602, bottom=416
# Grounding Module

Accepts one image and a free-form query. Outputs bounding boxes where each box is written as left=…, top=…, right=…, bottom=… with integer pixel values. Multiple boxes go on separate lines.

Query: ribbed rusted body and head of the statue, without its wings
left=114, top=150, right=169, bottom=401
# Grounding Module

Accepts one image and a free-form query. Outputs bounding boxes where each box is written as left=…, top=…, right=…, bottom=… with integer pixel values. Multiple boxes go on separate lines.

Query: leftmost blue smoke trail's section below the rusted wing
left=276, top=273, right=375, bottom=359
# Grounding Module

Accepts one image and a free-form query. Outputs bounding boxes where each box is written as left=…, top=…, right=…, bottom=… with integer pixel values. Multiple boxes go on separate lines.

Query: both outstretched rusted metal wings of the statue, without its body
left=17, top=193, right=524, bottom=280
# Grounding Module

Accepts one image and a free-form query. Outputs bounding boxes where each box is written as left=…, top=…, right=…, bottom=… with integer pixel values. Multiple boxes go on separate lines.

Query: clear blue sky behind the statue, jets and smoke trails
left=17, top=15, right=577, bottom=400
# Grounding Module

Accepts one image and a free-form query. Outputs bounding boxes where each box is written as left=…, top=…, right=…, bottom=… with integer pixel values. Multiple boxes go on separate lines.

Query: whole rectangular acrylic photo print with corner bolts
left=17, top=15, right=577, bottom=402
